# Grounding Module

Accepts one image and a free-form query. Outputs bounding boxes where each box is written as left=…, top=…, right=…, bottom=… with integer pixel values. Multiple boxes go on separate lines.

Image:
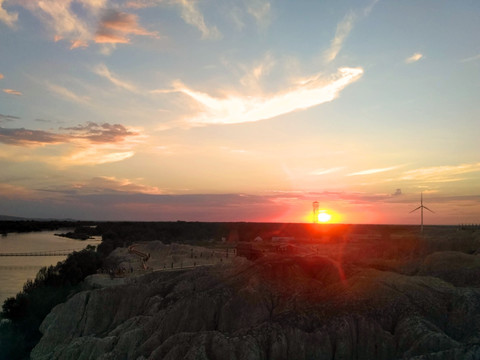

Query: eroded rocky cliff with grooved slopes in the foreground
left=31, top=252, right=480, bottom=360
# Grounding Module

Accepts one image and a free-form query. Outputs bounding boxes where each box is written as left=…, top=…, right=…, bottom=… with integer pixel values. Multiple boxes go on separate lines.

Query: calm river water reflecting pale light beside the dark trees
left=0, top=229, right=100, bottom=305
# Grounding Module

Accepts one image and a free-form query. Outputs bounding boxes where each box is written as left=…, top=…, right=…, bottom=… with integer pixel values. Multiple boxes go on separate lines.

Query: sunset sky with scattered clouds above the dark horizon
left=0, top=0, right=480, bottom=224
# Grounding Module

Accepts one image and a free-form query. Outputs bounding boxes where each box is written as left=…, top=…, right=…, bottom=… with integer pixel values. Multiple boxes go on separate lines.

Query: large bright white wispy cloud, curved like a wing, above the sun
left=176, top=68, right=363, bottom=125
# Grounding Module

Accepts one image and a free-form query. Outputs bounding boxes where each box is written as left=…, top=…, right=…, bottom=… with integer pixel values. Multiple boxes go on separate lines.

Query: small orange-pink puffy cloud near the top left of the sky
left=95, top=9, right=158, bottom=44
